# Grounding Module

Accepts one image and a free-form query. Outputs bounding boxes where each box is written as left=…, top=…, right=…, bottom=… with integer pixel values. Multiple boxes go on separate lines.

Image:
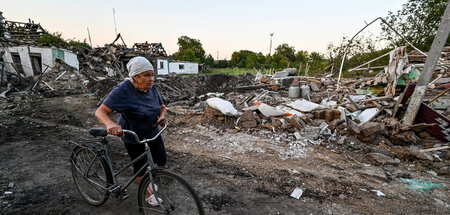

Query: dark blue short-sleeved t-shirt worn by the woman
left=103, top=80, right=164, bottom=143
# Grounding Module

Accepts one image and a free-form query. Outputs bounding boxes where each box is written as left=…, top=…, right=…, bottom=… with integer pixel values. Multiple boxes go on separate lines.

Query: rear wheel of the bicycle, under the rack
left=70, top=146, right=113, bottom=206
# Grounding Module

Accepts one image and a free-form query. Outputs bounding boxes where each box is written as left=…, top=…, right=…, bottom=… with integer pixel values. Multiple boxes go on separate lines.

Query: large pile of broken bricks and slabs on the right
left=194, top=47, right=450, bottom=175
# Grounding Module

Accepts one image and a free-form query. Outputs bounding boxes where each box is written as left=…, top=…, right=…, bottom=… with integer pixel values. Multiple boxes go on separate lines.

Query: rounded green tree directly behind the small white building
left=175, top=36, right=205, bottom=63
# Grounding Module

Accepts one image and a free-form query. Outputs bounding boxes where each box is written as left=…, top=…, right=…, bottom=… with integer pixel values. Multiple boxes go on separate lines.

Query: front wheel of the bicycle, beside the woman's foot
left=138, top=170, right=205, bottom=214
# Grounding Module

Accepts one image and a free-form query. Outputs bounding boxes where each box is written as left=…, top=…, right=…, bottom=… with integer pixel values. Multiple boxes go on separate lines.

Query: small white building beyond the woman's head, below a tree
left=156, top=59, right=199, bottom=75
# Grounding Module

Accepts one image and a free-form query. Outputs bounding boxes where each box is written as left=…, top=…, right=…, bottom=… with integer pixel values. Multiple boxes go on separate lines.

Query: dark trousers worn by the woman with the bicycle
left=124, top=136, right=167, bottom=176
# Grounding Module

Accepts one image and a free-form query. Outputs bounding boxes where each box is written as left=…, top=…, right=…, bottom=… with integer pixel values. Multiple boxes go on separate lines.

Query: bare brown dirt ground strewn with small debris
left=0, top=88, right=450, bottom=214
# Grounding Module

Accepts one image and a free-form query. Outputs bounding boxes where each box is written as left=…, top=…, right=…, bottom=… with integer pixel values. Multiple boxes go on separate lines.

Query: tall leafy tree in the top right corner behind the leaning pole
left=382, top=0, right=450, bottom=51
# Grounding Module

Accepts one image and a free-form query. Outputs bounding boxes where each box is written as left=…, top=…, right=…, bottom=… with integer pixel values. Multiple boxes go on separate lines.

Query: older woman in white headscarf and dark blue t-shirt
left=95, top=57, right=166, bottom=206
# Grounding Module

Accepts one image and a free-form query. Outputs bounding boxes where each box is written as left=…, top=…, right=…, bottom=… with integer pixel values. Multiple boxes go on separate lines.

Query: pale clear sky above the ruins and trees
left=0, top=0, right=407, bottom=59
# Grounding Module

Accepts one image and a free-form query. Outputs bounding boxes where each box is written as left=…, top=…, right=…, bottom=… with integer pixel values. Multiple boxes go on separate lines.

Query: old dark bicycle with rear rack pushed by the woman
left=70, top=124, right=204, bottom=214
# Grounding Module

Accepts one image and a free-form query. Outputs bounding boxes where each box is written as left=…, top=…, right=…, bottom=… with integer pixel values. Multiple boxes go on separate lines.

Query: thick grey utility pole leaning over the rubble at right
left=403, top=1, right=450, bottom=125
